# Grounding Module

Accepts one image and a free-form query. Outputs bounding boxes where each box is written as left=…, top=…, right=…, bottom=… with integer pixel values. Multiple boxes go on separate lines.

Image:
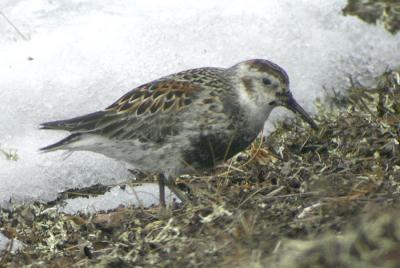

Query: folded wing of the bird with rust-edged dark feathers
left=41, top=79, right=200, bottom=142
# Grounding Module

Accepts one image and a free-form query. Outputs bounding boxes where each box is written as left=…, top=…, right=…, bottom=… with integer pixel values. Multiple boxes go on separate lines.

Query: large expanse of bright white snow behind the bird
left=0, top=0, right=400, bottom=208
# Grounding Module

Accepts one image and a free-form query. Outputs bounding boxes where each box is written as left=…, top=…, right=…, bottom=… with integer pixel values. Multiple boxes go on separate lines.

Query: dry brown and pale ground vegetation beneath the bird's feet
left=0, top=68, right=400, bottom=267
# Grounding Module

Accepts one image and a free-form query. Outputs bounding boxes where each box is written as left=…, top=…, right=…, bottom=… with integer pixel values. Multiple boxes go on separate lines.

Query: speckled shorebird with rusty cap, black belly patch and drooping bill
left=41, top=59, right=317, bottom=206
